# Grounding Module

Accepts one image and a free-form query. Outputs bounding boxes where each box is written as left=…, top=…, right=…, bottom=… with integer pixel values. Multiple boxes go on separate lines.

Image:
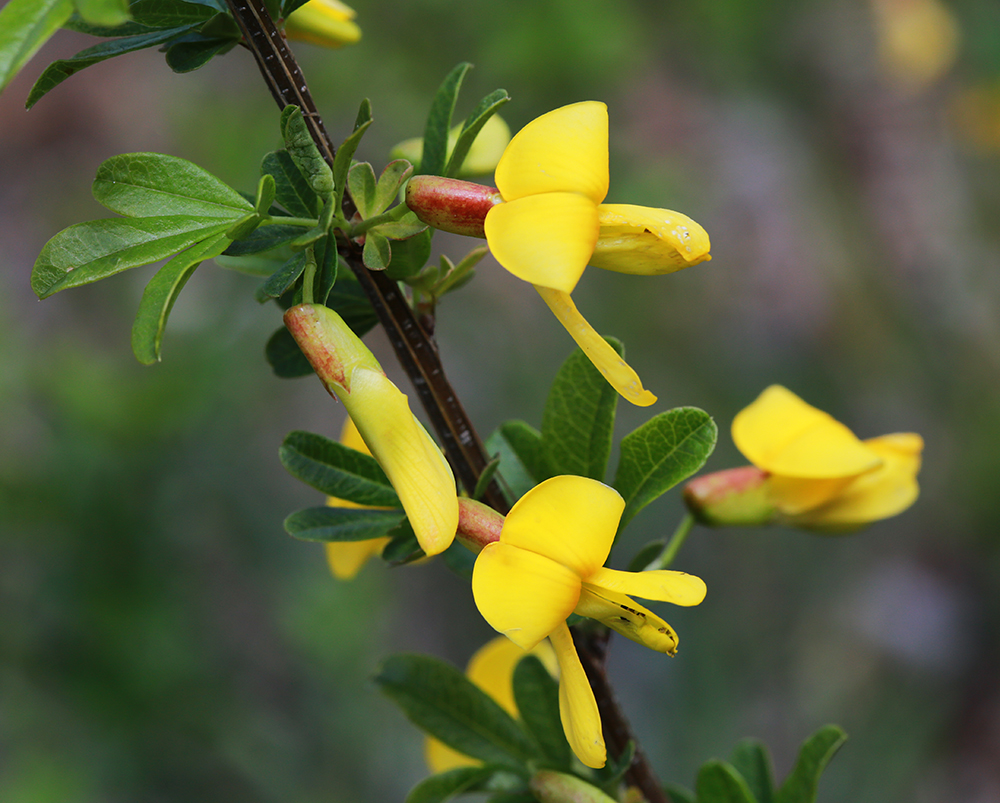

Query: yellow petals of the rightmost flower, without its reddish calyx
left=733, top=385, right=923, bottom=529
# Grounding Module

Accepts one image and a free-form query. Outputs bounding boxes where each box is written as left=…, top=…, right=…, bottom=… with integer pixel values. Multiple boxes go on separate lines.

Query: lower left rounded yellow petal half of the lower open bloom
left=472, top=542, right=580, bottom=650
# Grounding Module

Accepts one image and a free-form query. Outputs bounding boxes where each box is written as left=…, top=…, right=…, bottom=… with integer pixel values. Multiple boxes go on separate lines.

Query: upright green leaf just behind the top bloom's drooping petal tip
left=542, top=338, right=622, bottom=482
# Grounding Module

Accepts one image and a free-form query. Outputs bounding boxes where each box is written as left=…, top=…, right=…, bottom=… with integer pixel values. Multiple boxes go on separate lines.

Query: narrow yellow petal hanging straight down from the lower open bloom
left=549, top=622, right=608, bottom=769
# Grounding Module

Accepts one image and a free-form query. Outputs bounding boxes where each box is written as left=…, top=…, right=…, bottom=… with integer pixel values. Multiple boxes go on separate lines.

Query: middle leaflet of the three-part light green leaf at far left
left=31, top=215, right=229, bottom=298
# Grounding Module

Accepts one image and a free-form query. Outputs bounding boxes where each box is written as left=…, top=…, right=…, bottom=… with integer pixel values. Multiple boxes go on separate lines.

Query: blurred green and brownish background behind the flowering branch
left=0, top=0, right=1000, bottom=803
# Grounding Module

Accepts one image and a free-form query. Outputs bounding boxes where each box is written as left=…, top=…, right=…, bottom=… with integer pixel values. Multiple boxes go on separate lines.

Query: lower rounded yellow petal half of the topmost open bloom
left=484, top=192, right=598, bottom=293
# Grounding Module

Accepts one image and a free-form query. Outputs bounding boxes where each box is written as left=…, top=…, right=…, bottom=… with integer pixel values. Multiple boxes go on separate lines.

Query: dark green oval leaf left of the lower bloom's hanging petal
left=375, top=655, right=535, bottom=772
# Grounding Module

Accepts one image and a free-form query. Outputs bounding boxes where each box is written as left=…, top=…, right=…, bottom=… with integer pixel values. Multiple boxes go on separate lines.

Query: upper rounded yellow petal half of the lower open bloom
left=500, top=474, right=625, bottom=580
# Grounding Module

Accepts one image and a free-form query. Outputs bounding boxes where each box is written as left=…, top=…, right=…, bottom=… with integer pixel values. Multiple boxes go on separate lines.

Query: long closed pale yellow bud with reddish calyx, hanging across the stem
left=285, top=304, right=458, bottom=555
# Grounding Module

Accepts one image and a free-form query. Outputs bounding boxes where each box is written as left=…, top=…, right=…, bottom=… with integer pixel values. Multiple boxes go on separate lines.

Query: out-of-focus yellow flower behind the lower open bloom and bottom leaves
left=424, top=636, right=559, bottom=773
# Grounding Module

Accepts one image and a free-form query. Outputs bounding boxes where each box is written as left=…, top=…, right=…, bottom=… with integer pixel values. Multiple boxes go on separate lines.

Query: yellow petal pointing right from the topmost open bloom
left=590, top=204, right=712, bottom=276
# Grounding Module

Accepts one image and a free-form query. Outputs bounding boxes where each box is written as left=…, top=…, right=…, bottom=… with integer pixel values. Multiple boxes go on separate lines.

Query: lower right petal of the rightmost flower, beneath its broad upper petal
left=793, top=433, right=923, bottom=529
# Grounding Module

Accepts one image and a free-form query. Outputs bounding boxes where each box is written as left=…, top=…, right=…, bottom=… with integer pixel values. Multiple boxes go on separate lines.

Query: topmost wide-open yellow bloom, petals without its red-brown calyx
left=485, top=101, right=711, bottom=406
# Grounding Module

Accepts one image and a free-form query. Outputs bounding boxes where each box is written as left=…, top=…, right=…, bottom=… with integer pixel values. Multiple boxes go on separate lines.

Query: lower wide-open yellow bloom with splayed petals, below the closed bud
left=472, top=476, right=705, bottom=768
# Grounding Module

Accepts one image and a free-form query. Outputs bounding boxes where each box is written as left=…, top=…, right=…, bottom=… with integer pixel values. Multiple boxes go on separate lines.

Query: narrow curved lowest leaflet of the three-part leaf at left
left=132, top=234, right=230, bottom=365
